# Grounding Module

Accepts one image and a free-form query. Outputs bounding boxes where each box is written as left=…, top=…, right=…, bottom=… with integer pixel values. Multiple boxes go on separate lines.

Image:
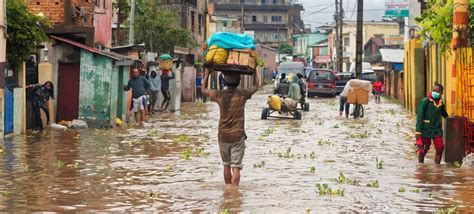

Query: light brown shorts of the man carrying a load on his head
left=219, top=137, right=245, bottom=169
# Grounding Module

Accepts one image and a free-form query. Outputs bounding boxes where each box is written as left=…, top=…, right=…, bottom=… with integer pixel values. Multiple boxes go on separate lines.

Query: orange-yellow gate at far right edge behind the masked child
left=456, top=48, right=474, bottom=153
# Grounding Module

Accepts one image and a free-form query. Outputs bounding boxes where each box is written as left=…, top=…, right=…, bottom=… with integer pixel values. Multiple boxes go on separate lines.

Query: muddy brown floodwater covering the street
left=0, top=85, right=474, bottom=213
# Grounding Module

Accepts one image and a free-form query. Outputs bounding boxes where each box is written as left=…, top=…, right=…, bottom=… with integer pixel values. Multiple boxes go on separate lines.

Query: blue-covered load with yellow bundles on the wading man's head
left=206, top=32, right=256, bottom=69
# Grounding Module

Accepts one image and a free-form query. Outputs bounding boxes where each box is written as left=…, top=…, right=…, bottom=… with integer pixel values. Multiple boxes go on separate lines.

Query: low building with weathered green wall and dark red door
left=48, top=36, right=135, bottom=127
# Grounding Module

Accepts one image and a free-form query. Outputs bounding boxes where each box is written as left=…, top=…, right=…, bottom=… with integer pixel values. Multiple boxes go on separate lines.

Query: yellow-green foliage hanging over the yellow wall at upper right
left=416, top=0, right=454, bottom=53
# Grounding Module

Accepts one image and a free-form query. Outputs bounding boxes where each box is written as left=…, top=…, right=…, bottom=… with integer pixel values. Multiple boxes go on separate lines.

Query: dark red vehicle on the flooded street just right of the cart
left=308, top=69, right=336, bottom=97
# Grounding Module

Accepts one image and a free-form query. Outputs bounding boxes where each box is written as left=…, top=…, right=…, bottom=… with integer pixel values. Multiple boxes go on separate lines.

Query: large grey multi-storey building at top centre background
left=210, top=0, right=304, bottom=48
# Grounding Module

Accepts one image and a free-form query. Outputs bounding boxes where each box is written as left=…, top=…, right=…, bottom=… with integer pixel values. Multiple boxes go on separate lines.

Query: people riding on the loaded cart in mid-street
left=273, top=73, right=307, bottom=110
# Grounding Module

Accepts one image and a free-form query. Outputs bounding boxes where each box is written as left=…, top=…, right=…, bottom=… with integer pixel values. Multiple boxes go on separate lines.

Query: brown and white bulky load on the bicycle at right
left=341, top=79, right=372, bottom=105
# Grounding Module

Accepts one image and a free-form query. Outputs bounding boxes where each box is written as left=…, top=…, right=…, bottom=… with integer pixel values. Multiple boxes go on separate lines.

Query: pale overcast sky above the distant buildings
left=298, top=0, right=385, bottom=29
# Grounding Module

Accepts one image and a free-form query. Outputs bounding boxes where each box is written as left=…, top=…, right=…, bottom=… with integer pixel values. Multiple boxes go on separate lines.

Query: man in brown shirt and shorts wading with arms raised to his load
left=202, top=69, right=259, bottom=187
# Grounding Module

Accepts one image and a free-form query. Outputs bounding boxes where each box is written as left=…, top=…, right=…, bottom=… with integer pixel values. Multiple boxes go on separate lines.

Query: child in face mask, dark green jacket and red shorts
left=416, top=84, right=448, bottom=164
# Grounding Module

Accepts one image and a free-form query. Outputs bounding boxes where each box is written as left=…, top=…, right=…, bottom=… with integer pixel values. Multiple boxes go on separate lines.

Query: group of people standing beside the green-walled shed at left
left=124, top=68, right=175, bottom=124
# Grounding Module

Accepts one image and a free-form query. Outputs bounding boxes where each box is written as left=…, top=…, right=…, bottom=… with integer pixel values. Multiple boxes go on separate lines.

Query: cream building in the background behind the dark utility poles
left=329, top=21, right=400, bottom=71
